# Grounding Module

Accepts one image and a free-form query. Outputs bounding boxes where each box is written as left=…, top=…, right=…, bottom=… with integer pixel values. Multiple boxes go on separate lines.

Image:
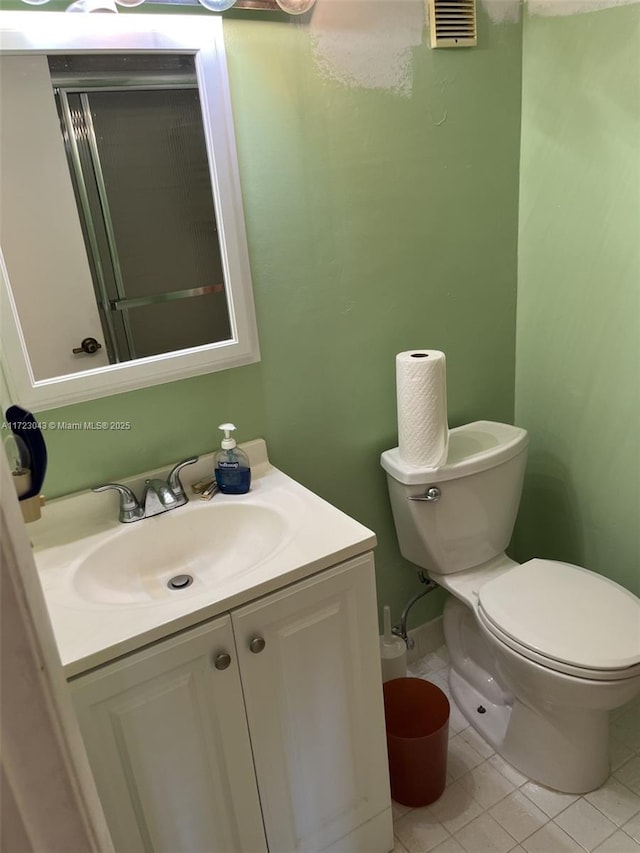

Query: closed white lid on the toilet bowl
left=478, top=559, right=640, bottom=671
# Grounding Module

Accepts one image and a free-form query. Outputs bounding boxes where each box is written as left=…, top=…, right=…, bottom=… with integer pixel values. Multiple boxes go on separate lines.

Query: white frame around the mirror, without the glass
left=0, top=12, right=260, bottom=410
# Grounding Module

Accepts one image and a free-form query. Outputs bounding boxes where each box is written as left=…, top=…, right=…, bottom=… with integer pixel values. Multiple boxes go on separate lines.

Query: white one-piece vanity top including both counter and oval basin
left=29, top=439, right=375, bottom=677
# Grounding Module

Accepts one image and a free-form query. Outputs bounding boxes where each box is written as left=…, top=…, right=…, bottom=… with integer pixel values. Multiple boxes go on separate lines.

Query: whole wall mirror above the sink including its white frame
left=0, top=12, right=259, bottom=409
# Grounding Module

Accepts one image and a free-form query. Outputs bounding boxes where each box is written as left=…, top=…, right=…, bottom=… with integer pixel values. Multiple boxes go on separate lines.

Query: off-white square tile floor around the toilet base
left=393, top=646, right=640, bottom=853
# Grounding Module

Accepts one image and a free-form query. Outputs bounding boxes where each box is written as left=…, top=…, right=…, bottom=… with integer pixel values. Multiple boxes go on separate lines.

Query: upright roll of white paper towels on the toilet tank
left=396, top=349, right=449, bottom=468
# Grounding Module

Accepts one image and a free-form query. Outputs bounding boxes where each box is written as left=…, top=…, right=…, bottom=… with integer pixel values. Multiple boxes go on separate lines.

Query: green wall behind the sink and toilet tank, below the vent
left=2, top=4, right=521, bottom=622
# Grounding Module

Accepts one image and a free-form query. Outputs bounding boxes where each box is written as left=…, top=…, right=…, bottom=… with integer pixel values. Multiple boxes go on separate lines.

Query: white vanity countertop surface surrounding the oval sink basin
left=29, top=439, right=376, bottom=677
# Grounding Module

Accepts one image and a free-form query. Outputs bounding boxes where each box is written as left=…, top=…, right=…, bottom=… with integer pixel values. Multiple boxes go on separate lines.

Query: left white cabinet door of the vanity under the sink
left=70, top=616, right=266, bottom=853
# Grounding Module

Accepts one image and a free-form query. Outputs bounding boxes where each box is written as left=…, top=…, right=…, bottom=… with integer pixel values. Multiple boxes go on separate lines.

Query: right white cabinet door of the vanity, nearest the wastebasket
left=232, top=555, right=393, bottom=853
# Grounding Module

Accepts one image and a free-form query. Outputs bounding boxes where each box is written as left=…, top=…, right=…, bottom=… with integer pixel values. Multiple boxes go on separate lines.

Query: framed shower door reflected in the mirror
left=48, top=54, right=231, bottom=364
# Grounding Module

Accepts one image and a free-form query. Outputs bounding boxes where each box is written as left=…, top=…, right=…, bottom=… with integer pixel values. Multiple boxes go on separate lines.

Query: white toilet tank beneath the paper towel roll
left=380, top=421, right=529, bottom=574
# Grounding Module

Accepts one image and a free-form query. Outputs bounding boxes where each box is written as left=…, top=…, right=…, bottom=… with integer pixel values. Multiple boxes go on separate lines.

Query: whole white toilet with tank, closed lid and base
left=381, top=421, right=640, bottom=794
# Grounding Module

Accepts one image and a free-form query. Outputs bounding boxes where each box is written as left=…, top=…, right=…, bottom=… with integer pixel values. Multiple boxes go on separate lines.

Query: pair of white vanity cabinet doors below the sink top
left=70, top=554, right=393, bottom=853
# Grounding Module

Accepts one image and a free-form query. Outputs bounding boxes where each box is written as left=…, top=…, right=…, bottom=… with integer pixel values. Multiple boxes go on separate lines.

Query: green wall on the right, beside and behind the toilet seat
left=516, top=5, right=640, bottom=593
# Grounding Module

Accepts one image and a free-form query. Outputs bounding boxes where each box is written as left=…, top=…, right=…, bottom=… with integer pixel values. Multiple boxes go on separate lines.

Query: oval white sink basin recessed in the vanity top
left=70, top=498, right=293, bottom=605
